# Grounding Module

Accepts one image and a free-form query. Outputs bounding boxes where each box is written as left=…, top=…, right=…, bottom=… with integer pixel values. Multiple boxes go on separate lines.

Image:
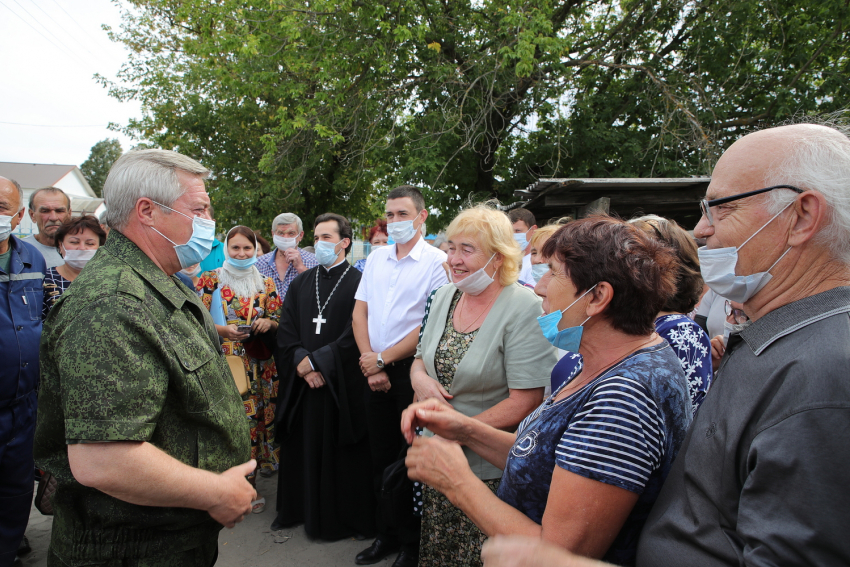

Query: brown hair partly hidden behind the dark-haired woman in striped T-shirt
left=629, top=215, right=704, bottom=313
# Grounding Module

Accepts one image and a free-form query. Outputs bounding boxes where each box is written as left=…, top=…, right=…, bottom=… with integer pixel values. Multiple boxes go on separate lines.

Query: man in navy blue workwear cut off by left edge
left=0, top=177, right=46, bottom=565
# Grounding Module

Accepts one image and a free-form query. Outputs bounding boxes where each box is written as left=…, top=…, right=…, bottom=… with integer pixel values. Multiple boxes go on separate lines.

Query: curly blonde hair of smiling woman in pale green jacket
left=446, top=204, right=522, bottom=287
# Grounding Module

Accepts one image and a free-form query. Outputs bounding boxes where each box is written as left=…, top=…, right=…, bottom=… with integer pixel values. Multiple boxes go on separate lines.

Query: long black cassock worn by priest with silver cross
left=275, top=262, right=375, bottom=540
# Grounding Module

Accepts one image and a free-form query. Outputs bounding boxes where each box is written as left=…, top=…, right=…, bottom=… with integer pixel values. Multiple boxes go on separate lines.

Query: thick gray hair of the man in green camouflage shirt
left=103, top=150, right=210, bottom=230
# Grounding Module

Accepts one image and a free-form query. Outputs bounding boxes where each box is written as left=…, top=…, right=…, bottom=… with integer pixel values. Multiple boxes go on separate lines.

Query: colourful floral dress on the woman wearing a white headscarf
left=196, top=271, right=283, bottom=479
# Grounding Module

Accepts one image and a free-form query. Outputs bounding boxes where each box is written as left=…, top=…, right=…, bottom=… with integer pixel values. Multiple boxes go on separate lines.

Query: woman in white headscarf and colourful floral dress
left=196, top=226, right=282, bottom=514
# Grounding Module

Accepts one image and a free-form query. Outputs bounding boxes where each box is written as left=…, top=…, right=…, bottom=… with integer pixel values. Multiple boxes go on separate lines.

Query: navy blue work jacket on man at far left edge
left=0, top=236, right=46, bottom=408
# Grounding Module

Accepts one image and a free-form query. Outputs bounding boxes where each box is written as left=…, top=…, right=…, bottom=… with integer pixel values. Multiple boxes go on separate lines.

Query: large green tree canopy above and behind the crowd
left=101, top=0, right=850, bottom=230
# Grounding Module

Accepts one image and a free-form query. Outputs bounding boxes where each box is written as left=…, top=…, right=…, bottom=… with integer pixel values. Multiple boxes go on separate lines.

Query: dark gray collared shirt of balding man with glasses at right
left=637, top=287, right=850, bottom=567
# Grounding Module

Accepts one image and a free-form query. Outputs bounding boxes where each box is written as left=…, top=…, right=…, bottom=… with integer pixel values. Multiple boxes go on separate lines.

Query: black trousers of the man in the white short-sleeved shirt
left=368, top=357, right=419, bottom=549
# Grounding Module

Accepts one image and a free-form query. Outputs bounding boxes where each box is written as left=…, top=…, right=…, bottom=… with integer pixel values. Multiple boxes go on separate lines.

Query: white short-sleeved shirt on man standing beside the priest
left=354, top=238, right=449, bottom=352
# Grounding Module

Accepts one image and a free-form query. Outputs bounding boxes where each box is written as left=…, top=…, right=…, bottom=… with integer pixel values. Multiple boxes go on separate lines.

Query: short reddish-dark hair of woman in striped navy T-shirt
left=543, top=215, right=678, bottom=335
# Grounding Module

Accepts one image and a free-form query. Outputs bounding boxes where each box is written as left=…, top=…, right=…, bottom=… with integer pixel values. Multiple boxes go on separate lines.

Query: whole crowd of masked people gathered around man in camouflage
left=0, top=120, right=850, bottom=567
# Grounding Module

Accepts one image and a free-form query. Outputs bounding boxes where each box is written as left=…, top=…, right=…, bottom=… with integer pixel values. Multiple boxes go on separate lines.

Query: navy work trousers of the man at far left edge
left=0, top=392, right=36, bottom=566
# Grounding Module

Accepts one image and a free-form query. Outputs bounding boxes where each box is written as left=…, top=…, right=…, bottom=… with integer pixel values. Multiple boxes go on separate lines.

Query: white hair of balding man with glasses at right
left=765, top=120, right=850, bottom=264
